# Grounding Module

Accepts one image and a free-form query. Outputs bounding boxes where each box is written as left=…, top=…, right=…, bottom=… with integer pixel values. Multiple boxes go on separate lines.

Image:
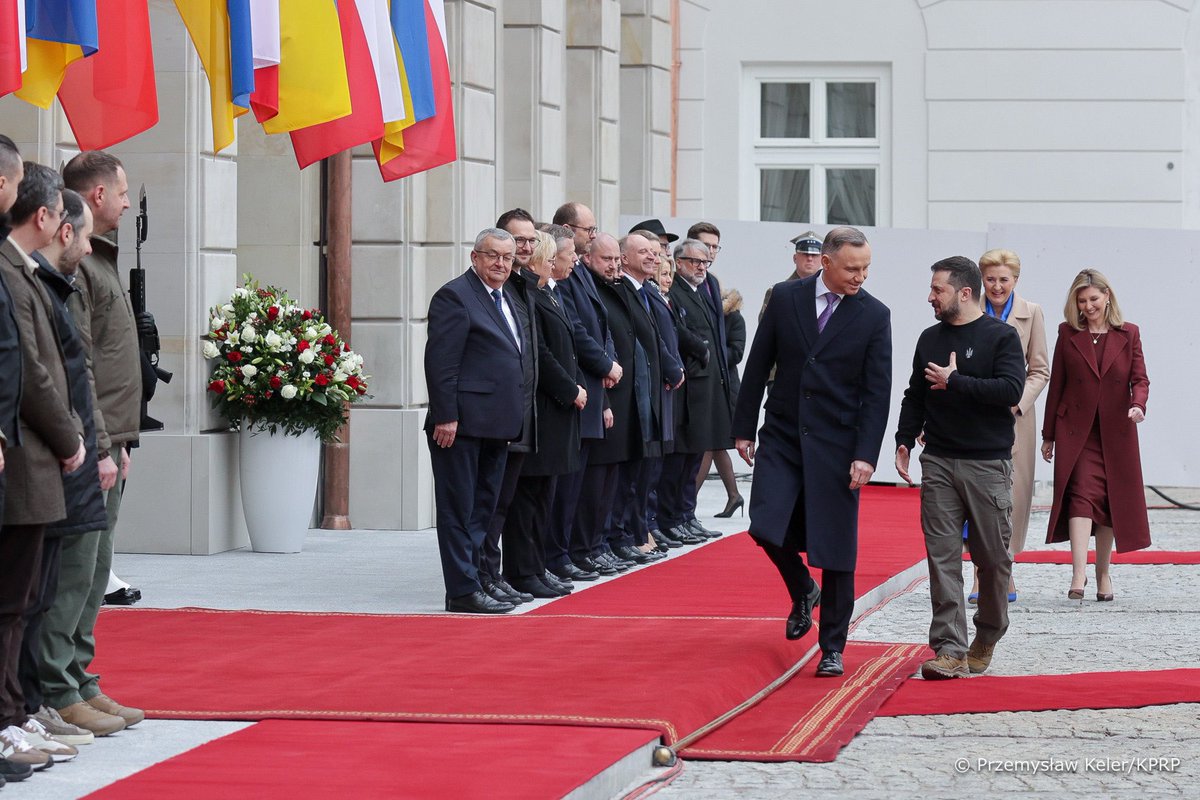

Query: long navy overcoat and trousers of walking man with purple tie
left=733, top=272, right=892, bottom=652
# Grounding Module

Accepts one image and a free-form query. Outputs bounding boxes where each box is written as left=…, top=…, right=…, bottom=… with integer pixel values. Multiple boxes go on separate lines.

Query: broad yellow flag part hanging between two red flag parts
left=263, top=0, right=352, bottom=133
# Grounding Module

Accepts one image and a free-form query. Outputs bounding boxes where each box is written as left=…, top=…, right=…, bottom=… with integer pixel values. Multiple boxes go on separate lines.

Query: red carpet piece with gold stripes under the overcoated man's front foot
left=680, top=642, right=929, bottom=762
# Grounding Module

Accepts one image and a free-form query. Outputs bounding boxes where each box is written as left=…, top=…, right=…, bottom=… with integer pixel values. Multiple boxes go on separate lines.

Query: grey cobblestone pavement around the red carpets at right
left=655, top=510, right=1200, bottom=800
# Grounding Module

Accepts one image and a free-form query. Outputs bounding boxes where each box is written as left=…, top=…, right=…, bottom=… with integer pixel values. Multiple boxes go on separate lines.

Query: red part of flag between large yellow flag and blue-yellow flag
left=290, top=0, right=383, bottom=169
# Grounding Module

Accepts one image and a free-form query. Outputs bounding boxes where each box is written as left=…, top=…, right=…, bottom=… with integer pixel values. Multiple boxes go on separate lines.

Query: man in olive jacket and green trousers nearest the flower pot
left=40, top=150, right=145, bottom=736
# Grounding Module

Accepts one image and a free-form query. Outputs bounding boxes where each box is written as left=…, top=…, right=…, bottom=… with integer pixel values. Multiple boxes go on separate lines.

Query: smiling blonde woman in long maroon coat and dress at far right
left=1042, top=270, right=1150, bottom=601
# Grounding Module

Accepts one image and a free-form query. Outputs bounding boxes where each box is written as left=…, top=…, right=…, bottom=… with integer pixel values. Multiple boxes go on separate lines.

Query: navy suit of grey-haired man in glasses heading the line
left=425, top=270, right=529, bottom=597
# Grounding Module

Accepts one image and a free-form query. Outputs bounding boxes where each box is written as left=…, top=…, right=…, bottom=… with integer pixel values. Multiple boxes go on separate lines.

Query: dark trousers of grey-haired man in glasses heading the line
left=427, top=437, right=509, bottom=597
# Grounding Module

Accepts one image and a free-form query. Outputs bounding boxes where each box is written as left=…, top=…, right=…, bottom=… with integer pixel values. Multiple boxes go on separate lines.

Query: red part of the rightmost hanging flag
left=374, top=0, right=458, bottom=181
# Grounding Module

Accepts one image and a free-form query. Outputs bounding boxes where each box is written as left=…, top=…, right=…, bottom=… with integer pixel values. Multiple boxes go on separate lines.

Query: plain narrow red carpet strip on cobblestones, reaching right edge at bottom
left=878, top=669, right=1200, bottom=717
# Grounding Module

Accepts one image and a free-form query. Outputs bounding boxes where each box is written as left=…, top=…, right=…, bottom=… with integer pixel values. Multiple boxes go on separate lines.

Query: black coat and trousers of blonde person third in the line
left=504, top=287, right=583, bottom=579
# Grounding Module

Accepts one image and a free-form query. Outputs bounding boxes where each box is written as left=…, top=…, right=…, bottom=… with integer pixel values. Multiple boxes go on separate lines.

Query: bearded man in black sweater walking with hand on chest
left=896, top=255, right=1025, bottom=680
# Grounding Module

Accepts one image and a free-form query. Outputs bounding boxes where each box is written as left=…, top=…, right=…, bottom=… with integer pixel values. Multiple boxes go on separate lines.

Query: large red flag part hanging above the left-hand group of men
left=59, top=0, right=158, bottom=150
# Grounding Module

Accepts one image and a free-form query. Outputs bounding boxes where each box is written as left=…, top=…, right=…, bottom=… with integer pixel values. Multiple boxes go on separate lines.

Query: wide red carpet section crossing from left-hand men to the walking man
left=96, top=609, right=816, bottom=744
